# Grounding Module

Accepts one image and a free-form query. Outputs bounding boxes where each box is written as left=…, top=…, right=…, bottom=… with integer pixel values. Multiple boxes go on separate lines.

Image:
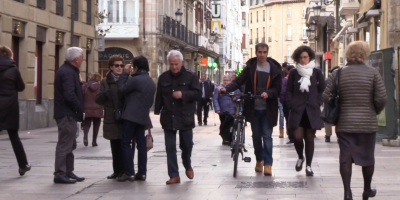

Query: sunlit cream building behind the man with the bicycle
left=249, top=0, right=307, bottom=64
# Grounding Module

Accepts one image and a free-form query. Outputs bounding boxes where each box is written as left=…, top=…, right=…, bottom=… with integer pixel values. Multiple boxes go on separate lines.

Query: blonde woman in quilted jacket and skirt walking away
left=323, top=41, right=387, bottom=200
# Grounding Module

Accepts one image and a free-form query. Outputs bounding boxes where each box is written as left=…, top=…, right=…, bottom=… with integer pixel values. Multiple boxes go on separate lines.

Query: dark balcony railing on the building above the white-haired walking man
left=161, top=16, right=199, bottom=47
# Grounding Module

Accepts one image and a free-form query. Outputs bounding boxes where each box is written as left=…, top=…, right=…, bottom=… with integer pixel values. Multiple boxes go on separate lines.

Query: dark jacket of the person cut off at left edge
left=0, top=57, right=25, bottom=130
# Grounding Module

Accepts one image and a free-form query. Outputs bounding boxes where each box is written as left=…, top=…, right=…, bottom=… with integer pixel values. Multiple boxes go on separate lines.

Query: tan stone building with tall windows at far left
left=0, top=0, right=98, bottom=130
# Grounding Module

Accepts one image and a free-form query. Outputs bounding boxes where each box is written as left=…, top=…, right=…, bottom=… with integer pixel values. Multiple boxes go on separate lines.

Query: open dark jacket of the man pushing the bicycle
left=226, top=57, right=282, bottom=127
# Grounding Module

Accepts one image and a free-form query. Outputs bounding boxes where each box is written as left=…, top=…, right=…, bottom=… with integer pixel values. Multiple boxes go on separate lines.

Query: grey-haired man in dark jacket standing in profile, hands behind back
left=54, top=47, right=85, bottom=183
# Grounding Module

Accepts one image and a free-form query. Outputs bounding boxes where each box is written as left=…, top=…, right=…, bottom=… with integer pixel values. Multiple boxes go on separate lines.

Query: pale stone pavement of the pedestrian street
left=0, top=114, right=400, bottom=200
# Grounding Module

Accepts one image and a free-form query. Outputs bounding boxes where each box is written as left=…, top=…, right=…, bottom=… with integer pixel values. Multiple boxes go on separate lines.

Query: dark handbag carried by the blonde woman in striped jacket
left=320, top=68, right=342, bottom=125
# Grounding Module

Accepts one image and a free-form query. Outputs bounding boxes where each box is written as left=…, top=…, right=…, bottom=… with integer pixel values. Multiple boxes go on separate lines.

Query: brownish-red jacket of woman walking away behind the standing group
left=82, top=81, right=103, bottom=118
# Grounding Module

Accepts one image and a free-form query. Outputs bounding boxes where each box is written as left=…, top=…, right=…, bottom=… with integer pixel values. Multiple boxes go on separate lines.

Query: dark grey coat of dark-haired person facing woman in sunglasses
left=118, top=72, right=156, bottom=126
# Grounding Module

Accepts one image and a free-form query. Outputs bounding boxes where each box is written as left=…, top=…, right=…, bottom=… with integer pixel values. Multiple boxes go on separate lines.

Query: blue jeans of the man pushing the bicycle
left=251, top=110, right=273, bottom=165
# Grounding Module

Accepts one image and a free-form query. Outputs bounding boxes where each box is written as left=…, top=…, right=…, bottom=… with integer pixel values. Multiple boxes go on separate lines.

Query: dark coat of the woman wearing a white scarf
left=286, top=68, right=325, bottom=130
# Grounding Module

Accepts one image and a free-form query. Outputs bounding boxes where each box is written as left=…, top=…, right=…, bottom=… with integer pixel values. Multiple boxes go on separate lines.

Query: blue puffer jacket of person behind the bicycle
left=213, top=85, right=240, bottom=115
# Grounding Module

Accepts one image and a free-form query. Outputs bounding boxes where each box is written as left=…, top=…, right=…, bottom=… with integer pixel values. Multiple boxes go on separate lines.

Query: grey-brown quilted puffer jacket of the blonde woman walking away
left=323, top=64, right=387, bottom=133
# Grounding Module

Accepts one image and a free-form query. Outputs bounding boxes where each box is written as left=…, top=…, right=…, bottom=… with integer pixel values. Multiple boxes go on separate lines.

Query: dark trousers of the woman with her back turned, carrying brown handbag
left=121, top=120, right=147, bottom=176
